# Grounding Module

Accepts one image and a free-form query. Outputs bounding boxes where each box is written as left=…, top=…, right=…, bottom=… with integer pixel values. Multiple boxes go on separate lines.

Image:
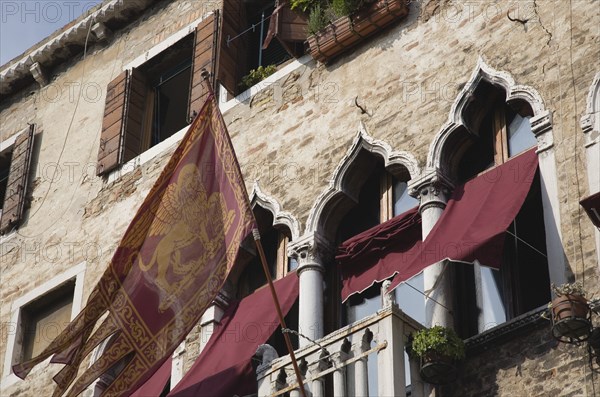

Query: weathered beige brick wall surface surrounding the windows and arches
left=0, top=0, right=600, bottom=395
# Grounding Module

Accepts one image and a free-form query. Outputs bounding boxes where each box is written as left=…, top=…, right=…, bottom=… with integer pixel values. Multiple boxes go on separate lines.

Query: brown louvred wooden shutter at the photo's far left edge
left=0, top=124, right=35, bottom=234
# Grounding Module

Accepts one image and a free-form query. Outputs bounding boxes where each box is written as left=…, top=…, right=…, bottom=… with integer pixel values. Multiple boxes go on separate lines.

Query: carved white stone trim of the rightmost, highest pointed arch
left=427, top=57, right=552, bottom=170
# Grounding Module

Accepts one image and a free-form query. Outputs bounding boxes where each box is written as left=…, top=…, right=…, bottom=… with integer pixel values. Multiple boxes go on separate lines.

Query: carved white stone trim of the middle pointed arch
left=305, top=122, right=421, bottom=241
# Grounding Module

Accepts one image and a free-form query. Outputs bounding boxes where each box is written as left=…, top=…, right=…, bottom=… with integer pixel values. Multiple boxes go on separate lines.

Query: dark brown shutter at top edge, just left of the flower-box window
left=217, top=0, right=248, bottom=95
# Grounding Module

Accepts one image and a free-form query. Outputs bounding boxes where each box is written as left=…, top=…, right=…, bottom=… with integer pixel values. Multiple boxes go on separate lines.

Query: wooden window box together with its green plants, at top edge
left=291, top=0, right=408, bottom=62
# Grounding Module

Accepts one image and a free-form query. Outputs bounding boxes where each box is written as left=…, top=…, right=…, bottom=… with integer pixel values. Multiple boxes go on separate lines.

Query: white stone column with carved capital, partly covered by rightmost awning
left=409, top=170, right=454, bottom=328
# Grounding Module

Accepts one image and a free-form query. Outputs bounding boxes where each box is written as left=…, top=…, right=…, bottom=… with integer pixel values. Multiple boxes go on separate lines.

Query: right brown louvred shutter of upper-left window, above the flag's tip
left=188, top=11, right=219, bottom=119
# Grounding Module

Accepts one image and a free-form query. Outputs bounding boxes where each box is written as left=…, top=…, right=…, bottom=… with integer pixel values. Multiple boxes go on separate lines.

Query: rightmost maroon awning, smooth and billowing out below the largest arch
left=385, top=149, right=538, bottom=289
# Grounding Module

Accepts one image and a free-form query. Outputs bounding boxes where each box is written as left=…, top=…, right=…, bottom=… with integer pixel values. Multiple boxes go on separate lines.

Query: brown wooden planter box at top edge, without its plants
left=307, top=0, right=408, bottom=63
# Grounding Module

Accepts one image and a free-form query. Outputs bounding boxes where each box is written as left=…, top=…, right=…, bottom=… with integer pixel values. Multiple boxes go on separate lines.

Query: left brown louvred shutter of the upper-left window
left=96, top=71, right=130, bottom=175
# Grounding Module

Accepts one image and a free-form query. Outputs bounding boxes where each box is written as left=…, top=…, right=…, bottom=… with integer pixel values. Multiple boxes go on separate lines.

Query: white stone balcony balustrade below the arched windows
left=257, top=304, right=424, bottom=397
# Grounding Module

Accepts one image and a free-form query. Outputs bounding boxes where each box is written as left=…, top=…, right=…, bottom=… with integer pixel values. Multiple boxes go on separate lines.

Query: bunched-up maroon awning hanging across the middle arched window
left=336, top=207, right=422, bottom=300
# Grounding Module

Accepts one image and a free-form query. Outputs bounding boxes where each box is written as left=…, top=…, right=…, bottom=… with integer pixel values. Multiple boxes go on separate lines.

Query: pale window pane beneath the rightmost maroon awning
left=480, top=266, right=506, bottom=331
